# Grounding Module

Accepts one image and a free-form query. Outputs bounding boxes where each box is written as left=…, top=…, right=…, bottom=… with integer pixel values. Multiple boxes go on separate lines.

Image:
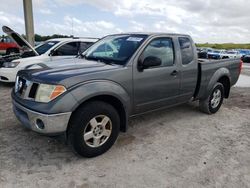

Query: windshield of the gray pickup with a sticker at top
left=83, top=34, right=147, bottom=65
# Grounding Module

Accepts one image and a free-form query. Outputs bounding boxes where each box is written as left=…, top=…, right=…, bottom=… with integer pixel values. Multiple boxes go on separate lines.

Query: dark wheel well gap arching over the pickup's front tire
left=72, top=95, right=127, bottom=132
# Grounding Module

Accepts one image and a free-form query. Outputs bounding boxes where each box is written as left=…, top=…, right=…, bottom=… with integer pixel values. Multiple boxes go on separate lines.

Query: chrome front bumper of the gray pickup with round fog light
left=13, top=100, right=71, bottom=135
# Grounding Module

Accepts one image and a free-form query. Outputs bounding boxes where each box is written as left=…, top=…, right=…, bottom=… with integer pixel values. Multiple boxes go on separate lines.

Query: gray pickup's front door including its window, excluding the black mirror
left=133, top=37, right=180, bottom=113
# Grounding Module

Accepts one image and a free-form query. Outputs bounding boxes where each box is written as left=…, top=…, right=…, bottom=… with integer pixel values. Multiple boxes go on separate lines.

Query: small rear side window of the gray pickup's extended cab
left=179, top=37, right=194, bottom=65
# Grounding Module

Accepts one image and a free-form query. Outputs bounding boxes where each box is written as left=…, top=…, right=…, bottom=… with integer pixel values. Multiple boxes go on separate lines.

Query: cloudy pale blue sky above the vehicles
left=0, top=0, right=250, bottom=43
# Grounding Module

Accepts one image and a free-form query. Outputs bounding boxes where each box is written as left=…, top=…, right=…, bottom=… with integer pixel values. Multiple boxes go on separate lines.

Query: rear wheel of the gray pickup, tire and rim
left=199, top=82, right=224, bottom=114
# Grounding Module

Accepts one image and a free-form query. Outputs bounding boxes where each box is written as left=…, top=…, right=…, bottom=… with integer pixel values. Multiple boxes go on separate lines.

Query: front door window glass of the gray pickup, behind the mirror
left=141, top=38, right=174, bottom=67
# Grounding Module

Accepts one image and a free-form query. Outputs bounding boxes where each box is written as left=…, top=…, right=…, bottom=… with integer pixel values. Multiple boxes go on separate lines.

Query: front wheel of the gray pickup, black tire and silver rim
left=68, top=101, right=120, bottom=158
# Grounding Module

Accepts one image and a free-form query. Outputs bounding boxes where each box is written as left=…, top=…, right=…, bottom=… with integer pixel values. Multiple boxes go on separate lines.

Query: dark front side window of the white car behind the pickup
left=53, top=42, right=78, bottom=56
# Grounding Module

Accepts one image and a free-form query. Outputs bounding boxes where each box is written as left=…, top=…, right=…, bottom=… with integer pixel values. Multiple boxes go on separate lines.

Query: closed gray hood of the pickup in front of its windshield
left=18, top=58, right=123, bottom=87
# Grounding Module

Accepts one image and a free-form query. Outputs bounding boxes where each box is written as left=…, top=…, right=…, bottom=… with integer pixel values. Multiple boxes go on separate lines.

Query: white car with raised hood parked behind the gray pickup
left=0, top=26, right=98, bottom=82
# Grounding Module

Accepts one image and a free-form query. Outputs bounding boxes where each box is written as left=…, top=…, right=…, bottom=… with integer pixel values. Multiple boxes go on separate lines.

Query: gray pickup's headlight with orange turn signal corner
left=35, top=84, right=66, bottom=103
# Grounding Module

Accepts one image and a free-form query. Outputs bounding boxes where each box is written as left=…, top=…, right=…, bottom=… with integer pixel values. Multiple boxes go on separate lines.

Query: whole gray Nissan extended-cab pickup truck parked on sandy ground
left=12, top=33, right=242, bottom=157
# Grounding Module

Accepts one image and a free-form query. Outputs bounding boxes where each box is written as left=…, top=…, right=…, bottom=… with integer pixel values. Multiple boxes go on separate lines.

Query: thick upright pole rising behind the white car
left=23, top=0, right=35, bottom=46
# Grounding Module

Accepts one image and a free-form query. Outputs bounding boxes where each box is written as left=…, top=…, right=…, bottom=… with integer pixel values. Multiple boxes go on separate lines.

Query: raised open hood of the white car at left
left=2, top=26, right=39, bottom=55
